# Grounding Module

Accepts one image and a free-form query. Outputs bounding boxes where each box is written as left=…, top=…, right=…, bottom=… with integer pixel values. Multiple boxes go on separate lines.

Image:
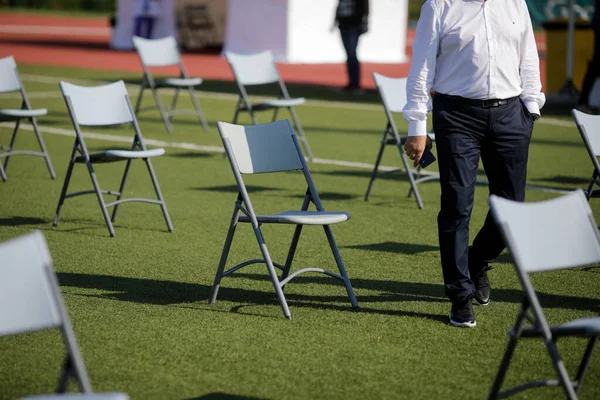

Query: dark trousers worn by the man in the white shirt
left=433, top=94, right=533, bottom=301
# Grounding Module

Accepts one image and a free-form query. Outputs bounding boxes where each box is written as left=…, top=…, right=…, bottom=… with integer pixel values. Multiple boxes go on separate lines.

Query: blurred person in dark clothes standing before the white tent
left=334, top=0, right=369, bottom=92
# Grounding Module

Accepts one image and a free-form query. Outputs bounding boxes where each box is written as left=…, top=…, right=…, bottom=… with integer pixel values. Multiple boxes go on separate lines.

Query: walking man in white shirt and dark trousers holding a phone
left=403, top=0, right=545, bottom=327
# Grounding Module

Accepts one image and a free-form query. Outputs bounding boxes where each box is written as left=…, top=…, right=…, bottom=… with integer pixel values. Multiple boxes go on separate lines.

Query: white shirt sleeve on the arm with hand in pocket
left=519, top=1, right=546, bottom=114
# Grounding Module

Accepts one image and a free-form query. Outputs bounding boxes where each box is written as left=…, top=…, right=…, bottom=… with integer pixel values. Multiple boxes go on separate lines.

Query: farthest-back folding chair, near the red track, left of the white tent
left=133, top=36, right=208, bottom=133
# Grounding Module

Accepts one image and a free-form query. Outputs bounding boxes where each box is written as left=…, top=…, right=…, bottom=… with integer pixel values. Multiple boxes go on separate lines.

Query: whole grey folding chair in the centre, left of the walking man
left=209, top=120, right=358, bottom=319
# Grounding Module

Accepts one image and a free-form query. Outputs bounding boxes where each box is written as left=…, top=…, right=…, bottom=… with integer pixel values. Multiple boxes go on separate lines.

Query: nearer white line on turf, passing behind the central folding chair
left=0, top=122, right=569, bottom=193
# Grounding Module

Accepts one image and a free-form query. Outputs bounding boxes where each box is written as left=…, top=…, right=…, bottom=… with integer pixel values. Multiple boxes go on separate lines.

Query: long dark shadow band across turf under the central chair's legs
left=57, top=271, right=600, bottom=323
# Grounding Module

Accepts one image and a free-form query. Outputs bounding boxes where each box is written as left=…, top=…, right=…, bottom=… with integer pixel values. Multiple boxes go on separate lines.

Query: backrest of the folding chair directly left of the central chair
left=60, top=81, right=134, bottom=126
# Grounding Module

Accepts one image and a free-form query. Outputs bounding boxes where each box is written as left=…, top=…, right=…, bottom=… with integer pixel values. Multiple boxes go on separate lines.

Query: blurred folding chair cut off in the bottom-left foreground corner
left=0, top=231, right=128, bottom=400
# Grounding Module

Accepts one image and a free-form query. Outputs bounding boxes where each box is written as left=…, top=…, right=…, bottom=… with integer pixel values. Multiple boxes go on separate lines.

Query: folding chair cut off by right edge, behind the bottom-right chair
left=571, top=110, right=600, bottom=200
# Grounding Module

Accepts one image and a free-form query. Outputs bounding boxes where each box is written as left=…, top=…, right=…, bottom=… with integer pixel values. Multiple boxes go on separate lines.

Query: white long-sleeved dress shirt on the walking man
left=403, top=0, right=546, bottom=136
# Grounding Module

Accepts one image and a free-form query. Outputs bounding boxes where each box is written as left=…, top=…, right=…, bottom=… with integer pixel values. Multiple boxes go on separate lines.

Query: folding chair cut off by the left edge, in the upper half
left=0, top=56, right=56, bottom=182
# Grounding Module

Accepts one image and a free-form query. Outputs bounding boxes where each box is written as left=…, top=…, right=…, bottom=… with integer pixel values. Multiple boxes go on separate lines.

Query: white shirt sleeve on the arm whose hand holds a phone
left=402, top=0, right=440, bottom=136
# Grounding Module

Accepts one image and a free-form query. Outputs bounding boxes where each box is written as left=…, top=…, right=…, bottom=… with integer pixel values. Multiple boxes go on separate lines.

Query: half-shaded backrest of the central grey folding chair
left=217, top=120, right=304, bottom=174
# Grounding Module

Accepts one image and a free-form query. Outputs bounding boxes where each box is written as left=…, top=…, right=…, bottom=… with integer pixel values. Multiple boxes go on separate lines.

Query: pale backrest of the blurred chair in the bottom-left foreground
left=0, top=231, right=63, bottom=336
